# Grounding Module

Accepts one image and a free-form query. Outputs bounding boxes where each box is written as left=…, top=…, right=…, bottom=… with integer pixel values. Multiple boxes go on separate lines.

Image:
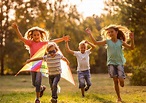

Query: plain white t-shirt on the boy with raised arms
left=74, top=50, right=91, bottom=71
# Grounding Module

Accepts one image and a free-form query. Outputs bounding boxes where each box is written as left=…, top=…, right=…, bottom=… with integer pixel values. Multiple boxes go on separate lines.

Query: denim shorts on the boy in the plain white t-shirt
left=77, top=70, right=91, bottom=88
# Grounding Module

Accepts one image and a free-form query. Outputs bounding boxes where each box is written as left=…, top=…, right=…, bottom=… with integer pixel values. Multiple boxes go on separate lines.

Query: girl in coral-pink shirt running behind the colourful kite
left=12, top=23, right=69, bottom=103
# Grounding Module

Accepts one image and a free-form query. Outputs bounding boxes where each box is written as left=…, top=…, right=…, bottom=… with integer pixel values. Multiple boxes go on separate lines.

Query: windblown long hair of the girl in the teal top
left=101, top=24, right=131, bottom=41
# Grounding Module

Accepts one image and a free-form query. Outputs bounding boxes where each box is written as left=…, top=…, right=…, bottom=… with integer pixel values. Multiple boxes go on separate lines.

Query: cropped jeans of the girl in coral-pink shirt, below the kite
left=31, top=72, right=42, bottom=92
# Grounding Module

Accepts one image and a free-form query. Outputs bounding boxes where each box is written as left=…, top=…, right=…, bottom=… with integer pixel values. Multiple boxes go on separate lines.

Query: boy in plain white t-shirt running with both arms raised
left=66, top=40, right=95, bottom=97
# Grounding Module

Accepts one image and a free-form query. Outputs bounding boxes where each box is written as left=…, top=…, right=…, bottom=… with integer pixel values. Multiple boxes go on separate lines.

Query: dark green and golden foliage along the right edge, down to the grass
left=102, top=0, right=146, bottom=85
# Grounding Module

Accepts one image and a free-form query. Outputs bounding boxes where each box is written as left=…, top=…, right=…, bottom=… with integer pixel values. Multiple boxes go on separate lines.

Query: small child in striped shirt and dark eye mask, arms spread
left=27, top=42, right=69, bottom=103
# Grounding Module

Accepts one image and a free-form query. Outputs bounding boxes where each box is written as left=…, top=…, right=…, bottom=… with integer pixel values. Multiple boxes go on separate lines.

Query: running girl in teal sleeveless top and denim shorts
left=86, top=25, right=134, bottom=102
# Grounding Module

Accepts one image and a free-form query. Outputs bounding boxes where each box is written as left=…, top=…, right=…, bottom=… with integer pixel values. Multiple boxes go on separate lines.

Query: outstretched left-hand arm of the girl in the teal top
left=86, top=28, right=106, bottom=45
